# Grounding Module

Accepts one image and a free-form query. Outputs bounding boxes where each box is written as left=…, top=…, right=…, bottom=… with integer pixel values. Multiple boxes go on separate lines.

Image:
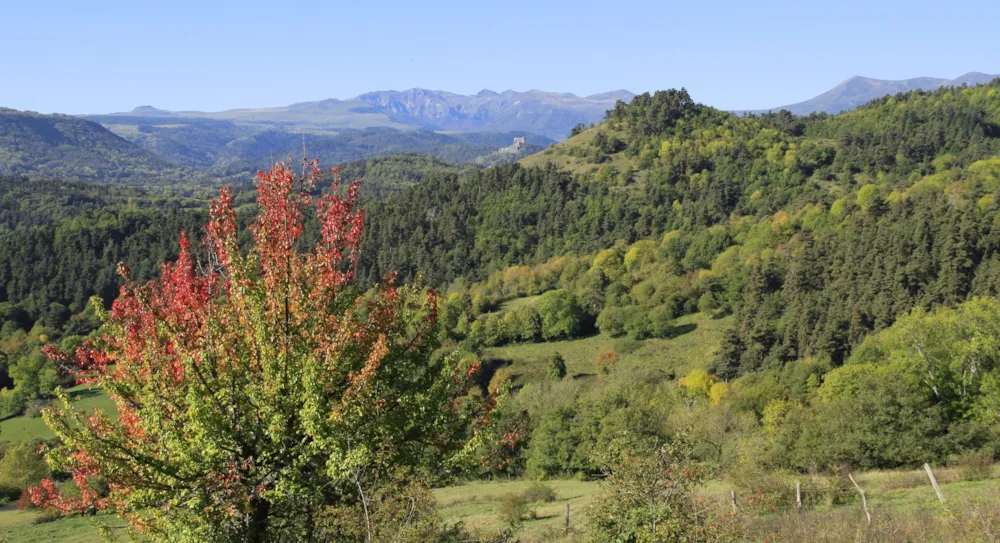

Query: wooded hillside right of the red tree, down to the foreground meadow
left=354, top=82, right=1000, bottom=477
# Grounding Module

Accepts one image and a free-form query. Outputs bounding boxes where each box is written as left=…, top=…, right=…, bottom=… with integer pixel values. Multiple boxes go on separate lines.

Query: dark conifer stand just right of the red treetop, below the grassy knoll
left=358, top=165, right=667, bottom=284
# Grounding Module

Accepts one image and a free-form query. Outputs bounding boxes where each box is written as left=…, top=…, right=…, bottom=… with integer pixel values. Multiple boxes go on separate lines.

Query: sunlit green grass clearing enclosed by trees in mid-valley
left=484, top=312, right=732, bottom=384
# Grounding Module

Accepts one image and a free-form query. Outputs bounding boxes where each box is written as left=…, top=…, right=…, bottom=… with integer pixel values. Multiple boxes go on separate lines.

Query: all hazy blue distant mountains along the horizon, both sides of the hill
left=7, top=72, right=997, bottom=184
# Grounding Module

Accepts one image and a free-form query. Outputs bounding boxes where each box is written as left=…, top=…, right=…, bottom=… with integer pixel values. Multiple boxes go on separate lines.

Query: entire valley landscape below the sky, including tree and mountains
left=0, top=62, right=1000, bottom=543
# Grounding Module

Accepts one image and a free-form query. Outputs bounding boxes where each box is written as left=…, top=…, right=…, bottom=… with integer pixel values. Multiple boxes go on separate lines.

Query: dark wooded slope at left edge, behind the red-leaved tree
left=0, top=185, right=206, bottom=418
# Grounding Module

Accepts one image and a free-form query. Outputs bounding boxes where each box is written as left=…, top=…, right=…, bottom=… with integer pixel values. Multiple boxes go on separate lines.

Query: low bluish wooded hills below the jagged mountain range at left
left=0, top=108, right=555, bottom=185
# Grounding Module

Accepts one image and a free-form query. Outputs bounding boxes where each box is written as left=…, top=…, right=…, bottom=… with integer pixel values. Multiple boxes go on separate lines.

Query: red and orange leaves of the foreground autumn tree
left=27, top=161, right=458, bottom=523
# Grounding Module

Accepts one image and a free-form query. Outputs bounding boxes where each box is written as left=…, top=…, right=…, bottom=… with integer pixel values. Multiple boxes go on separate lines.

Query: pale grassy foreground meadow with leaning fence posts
left=0, top=467, right=1000, bottom=543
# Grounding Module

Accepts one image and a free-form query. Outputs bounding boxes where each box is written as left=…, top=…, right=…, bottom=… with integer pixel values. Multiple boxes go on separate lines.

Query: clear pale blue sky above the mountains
left=0, top=0, right=1000, bottom=114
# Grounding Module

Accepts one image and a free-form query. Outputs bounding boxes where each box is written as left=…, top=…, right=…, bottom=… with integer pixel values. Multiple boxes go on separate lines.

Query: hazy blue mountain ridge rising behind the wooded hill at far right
left=754, top=72, right=1000, bottom=115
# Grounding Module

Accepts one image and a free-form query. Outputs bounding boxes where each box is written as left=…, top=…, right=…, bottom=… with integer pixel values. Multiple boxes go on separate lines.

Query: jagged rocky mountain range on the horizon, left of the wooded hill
left=103, top=89, right=634, bottom=139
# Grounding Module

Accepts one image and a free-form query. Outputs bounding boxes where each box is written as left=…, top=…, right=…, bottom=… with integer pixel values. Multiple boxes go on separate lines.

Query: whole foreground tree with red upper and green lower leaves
left=30, top=163, right=482, bottom=541
